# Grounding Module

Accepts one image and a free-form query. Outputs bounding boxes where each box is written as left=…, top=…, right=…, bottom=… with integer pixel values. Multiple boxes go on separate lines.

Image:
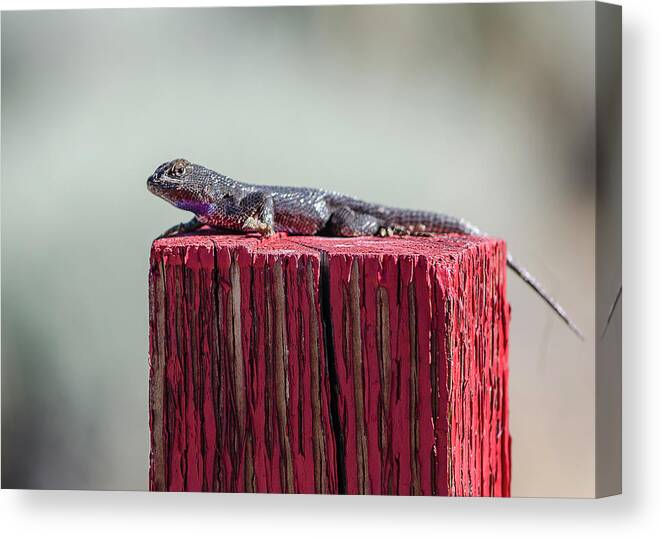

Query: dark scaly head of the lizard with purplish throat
left=147, top=159, right=218, bottom=214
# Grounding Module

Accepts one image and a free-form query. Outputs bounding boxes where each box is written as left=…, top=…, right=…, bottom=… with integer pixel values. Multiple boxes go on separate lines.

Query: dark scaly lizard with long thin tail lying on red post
left=147, top=159, right=583, bottom=339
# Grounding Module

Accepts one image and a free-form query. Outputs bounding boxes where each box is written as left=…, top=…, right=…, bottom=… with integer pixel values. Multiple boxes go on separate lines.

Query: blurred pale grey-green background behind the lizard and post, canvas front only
left=1, top=2, right=595, bottom=496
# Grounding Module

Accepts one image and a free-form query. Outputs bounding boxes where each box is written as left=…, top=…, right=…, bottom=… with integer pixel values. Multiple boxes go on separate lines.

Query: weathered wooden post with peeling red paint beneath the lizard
left=149, top=235, right=510, bottom=495
